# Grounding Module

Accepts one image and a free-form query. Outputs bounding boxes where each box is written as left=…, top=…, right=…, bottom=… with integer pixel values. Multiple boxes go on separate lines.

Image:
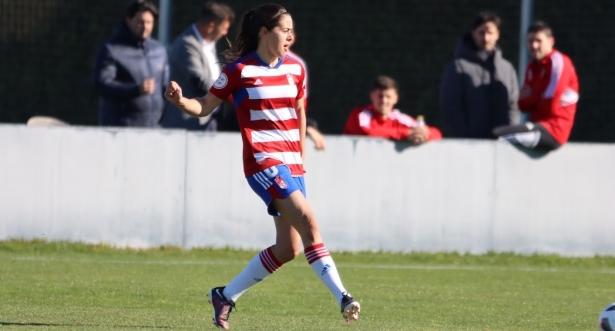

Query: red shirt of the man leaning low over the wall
left=344, top=105, right=442, bottom=141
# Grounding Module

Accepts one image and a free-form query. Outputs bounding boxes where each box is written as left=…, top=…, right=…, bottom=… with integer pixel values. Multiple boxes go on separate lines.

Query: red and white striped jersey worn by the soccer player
left=209, top=52, right=305, bottom=177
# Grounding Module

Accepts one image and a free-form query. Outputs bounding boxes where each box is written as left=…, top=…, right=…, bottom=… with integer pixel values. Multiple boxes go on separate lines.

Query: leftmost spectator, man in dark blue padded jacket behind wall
left=94, top=0, right=169, bottom=127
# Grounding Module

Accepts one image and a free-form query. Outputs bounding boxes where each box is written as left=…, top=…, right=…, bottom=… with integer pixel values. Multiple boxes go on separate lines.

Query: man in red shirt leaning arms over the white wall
left=343, top=76, right=442, bottom=144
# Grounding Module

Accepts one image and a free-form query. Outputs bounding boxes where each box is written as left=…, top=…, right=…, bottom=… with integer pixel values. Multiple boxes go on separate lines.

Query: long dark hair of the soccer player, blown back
left=222, top=3, right=289, bottom=64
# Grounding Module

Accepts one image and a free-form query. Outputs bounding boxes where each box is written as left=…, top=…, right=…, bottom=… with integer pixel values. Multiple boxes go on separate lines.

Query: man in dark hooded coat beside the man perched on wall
left=440, top=12, right=519, bottom=138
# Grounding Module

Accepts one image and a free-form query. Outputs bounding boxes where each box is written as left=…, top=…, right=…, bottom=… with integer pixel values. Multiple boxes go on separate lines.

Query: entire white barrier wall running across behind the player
left=0, top=125, right=615, bottom=255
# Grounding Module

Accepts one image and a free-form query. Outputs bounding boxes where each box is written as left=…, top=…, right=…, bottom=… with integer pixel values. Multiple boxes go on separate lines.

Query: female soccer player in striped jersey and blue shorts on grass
left=165, top=4, right=360, bottom=329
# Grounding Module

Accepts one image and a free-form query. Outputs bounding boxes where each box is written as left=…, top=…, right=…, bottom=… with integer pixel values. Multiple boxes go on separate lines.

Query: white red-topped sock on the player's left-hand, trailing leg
left=222, top=247, right=282, bottom=302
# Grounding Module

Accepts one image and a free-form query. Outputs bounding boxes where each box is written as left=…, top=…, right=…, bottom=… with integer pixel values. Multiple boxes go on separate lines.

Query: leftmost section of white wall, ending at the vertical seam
left=0, top=126, right=186, bottom=246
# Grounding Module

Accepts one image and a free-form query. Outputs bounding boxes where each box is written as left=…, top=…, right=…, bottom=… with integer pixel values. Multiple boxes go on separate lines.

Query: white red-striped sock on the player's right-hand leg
left=304, top=243, right=346, bottom=304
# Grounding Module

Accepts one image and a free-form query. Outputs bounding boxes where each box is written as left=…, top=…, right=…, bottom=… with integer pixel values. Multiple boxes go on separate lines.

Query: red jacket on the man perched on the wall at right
left=519, top=50, right=579, bottom=145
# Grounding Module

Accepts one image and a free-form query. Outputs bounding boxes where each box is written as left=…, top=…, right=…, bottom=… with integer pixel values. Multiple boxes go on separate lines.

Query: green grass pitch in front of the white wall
left=0, top=241, right=615, bottom=331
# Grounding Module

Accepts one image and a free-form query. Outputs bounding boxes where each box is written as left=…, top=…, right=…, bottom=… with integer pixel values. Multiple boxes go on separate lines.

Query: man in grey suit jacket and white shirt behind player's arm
left=162, top=2, right=235, bottom=131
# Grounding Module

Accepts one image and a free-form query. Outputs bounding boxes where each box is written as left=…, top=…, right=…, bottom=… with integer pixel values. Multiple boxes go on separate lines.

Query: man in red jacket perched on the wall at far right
left=493, top=21, right=579, bottom=151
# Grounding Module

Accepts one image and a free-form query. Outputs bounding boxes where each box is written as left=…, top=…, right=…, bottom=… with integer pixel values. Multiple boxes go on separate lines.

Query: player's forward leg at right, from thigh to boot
left=272, top=191, right=360, bottom=322
